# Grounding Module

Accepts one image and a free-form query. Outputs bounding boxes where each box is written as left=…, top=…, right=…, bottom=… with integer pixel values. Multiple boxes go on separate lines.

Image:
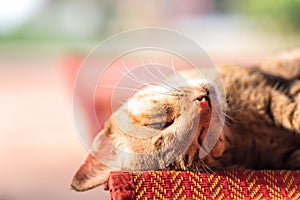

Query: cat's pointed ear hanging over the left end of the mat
left=71, top=154, right=111, bottom=191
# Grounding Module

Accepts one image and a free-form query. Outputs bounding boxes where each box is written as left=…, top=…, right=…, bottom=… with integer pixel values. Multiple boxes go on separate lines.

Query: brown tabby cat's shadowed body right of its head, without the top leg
left=206, top=64, right=300, bottom=169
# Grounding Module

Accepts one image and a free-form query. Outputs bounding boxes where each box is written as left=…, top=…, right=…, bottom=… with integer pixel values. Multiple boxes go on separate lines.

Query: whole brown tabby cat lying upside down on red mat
left=71, top=50, right=300, bottom=191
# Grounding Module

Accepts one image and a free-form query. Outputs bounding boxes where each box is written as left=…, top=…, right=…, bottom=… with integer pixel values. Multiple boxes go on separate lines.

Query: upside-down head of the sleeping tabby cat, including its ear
left=72, top=71, right=224, bottom=191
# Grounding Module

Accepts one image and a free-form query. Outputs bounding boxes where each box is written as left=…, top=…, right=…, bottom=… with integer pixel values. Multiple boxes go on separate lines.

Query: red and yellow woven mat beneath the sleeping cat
left=106, top=170, right=300, bottom=200
